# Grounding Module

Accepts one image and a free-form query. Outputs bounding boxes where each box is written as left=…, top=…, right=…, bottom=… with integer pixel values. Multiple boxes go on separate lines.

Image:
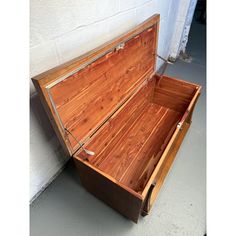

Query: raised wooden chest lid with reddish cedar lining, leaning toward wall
left=32, top=15, right=159, bottom=155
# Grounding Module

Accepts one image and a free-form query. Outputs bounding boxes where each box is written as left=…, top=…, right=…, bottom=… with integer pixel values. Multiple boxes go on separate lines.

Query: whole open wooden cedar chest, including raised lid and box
left=33, top=15, right=201, bottom=222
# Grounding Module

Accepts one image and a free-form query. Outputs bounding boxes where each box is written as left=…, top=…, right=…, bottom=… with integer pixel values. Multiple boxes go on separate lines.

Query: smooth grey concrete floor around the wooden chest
left=30, top=19, right=206, bottom=236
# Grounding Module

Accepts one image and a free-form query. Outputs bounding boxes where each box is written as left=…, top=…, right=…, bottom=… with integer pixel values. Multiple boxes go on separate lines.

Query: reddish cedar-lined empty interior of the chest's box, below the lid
left=74, top=75, right=196, bottom=194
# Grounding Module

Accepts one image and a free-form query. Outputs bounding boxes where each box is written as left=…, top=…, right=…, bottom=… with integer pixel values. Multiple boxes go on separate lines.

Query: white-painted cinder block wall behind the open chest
left=30, top=0, right=187, bottom=200
